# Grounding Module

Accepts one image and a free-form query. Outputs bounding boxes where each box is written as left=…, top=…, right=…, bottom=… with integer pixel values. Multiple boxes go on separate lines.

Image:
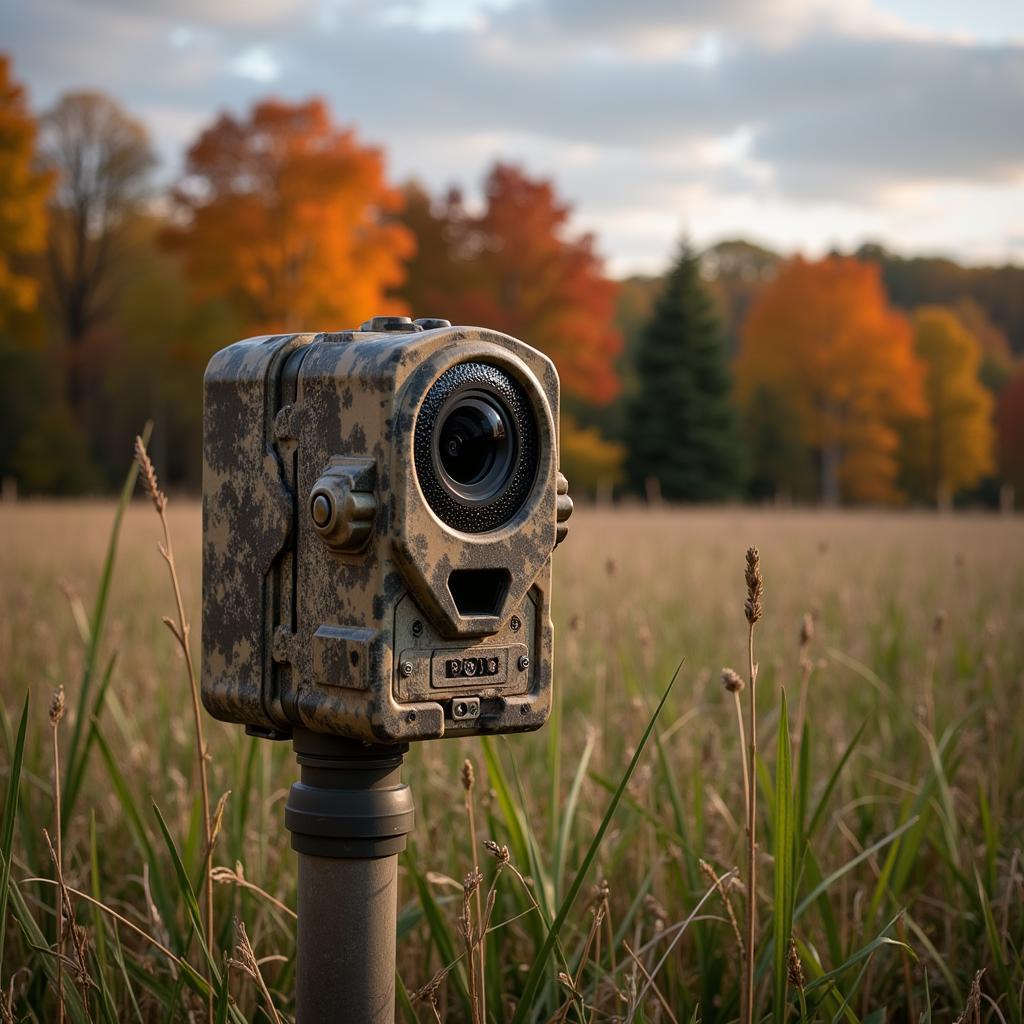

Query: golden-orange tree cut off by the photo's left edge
left=0, top=54, right=52, bottom=330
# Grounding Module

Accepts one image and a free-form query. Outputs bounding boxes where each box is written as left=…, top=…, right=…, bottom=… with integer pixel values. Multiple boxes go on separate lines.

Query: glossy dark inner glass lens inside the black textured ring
left=436, top=392, right=516, bottom=501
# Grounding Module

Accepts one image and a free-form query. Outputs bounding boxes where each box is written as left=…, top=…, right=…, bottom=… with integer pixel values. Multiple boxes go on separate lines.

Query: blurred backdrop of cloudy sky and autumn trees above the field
left=0, top=0, right=1024, bottom=509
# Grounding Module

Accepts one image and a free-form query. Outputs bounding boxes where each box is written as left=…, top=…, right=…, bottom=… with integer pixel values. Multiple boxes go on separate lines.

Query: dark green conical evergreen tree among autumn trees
left=626, top=243, right=742, bottom=501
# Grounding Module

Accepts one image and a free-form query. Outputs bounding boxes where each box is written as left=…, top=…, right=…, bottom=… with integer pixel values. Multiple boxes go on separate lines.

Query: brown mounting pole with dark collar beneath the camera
left=285, top=729, right=415, bottom=1024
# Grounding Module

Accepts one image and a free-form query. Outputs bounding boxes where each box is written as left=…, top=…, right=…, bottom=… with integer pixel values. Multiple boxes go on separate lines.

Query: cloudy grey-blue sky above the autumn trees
left=0, top=0, right=1024, bottom=274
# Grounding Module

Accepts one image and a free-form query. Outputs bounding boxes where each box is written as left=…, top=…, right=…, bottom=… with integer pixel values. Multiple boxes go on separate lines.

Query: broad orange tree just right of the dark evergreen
left=736, top=257, right=926, bottom=504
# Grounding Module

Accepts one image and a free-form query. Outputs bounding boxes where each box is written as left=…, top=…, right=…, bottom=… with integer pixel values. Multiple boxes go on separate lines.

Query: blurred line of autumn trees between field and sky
left=0, top=56, right=1024, bottom=502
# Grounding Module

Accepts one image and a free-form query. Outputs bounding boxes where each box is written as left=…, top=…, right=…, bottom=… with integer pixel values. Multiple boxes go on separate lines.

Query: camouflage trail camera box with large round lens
left=203, top=316, right=572, bottom=743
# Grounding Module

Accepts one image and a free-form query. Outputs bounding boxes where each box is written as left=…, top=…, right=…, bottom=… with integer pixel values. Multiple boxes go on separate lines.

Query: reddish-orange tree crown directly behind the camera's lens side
left=403, top=164, right=622, bottom=404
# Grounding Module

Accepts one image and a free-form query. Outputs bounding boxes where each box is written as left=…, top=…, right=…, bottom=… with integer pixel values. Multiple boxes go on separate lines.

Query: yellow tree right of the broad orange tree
left=902, top=306, right=995, bottom=504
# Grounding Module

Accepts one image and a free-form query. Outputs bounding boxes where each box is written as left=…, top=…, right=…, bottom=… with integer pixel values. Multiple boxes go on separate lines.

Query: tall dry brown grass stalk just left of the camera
left=135, top=437, right=216, bottom=1021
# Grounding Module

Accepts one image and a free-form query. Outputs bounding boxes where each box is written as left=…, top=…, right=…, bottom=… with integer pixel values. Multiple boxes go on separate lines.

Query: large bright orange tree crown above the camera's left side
left=166, top=99, right=414, bottom=331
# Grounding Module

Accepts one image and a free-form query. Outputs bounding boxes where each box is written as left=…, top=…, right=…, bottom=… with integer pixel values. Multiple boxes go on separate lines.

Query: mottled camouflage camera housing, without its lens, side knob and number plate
left=203, top=328, right=571, bottom=742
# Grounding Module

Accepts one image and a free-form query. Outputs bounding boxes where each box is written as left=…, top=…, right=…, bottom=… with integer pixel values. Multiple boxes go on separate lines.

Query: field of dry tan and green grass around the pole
left=0, top=491, right=1024, bottom=1024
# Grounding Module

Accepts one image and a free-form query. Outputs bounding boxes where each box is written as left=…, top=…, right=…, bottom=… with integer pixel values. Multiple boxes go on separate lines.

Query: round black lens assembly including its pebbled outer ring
left=414, top=362, right=539, bottom=534
